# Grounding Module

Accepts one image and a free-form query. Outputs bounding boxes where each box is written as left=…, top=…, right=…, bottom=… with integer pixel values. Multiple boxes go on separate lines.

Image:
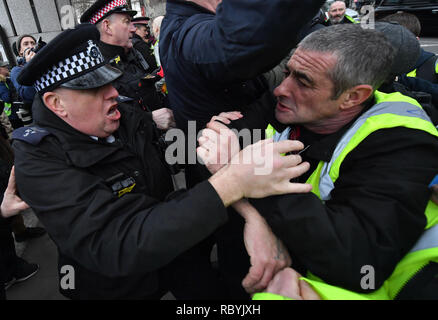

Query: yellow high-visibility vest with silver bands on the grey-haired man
left=254, top=91, right=438, bottom=300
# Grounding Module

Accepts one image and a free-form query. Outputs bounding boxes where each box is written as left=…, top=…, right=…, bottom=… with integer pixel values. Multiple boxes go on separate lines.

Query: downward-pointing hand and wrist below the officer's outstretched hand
left=233, top=200, right=291, bottom=293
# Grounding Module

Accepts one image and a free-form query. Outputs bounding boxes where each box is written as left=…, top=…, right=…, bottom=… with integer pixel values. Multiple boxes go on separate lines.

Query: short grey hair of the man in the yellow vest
left=298, top=24, right=395, bottom=100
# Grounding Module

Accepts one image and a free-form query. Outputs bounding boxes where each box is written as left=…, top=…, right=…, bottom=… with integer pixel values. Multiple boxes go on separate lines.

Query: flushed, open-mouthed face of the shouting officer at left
left=50, top=84, right=121, bottom=138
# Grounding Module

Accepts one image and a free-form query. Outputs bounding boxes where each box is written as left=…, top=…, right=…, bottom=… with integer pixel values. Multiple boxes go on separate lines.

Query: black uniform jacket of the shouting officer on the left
left=13, top=99, right=227, bottom=299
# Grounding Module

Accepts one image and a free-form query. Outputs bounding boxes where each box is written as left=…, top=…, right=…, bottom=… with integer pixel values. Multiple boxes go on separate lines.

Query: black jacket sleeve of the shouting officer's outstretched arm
left=13, top=137, right=227, bottom=277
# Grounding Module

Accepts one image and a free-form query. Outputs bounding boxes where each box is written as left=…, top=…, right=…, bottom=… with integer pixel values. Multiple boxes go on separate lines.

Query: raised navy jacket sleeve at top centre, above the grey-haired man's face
left=177, top=0, right=324, bottom=83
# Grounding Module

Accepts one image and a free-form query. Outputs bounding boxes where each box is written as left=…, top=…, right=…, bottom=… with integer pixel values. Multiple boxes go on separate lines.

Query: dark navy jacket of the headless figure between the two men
left=160, top=0, right=324, bottom=129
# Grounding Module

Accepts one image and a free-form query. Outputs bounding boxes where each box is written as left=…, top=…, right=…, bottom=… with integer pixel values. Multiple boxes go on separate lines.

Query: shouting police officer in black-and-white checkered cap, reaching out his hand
left=13, top=24, right=310, bottom=299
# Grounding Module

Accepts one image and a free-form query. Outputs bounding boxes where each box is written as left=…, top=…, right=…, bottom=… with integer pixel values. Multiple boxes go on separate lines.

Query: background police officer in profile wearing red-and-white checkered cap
left=81, top=0, right=175, bottom=130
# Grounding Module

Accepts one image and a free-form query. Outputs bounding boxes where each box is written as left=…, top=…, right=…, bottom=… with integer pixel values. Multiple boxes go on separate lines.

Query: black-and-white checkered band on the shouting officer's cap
left=35, top=51, right=104, bottom=92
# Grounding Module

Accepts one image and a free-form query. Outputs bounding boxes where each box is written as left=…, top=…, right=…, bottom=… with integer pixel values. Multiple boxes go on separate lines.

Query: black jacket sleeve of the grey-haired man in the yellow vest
left=254, top=128, right=438, bottom=291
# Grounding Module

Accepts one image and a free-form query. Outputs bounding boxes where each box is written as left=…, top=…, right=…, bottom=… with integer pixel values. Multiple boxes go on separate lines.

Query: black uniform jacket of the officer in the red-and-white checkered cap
left=99, top=42, right=163, bottom=111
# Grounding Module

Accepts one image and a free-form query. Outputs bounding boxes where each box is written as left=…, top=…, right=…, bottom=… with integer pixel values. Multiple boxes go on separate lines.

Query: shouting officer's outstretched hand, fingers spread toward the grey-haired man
left=209, top=139, right=312, bottom=206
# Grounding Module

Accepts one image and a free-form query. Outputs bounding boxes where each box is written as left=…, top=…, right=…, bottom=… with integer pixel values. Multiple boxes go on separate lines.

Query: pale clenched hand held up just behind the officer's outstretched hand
left=197, top=120, right=240, bottom=174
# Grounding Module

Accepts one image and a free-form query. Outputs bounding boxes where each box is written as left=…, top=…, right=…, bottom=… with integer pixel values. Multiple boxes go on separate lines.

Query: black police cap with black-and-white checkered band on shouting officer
left=17, top=23, right=122, bottom=95
